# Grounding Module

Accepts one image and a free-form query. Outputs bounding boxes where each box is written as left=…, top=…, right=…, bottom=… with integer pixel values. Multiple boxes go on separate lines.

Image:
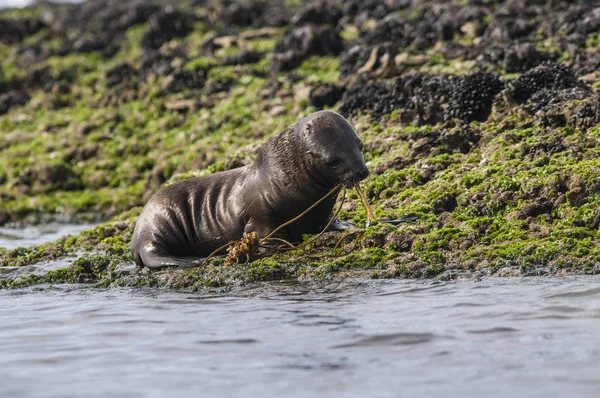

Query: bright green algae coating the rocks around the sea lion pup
left=0, top=2, right=600, bottom=289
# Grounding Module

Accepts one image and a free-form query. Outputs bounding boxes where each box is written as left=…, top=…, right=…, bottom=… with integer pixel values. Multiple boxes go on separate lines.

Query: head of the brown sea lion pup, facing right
left=296, top=111, right=369, bottom=187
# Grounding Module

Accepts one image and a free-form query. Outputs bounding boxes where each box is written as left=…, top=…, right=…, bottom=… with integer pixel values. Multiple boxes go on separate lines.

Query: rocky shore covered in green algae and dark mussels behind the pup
left=0, top=0, right=600, bottom=289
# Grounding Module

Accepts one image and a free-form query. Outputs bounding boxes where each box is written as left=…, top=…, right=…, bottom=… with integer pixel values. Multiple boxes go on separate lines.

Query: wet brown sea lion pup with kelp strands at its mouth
left=131, top=111, right=369, bottom=269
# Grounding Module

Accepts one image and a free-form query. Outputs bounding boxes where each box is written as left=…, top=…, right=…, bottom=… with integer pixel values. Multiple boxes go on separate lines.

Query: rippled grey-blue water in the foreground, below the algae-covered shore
left=0, top=277, right=600, bottom=397
